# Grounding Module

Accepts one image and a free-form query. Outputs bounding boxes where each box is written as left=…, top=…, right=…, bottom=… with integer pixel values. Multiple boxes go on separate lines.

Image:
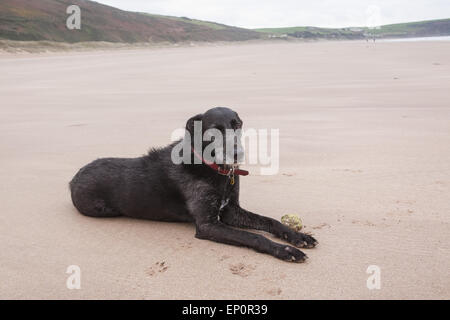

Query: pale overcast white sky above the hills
left=96, top=0, right=450, bottom=28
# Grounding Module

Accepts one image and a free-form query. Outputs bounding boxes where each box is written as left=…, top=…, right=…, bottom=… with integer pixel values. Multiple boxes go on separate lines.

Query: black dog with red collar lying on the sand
left=70, top=108, right=317, bottom=262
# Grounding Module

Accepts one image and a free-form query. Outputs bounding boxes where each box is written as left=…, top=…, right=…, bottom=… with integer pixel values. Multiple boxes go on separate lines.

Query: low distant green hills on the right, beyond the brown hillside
left=255, top=19, right=450, bottom=39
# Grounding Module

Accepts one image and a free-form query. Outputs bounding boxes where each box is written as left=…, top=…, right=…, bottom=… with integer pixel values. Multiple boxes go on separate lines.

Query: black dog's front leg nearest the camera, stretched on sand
left=195, top=221, right=307, bottom=262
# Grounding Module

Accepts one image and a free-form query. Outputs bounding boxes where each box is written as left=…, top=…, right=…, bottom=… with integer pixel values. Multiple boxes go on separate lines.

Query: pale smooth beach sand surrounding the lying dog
left=0, top=42, right=450, bottom=299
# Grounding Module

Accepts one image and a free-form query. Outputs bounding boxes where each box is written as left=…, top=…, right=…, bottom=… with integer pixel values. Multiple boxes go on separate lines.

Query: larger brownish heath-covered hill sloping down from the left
left=0, top=0, right=261, bottom=43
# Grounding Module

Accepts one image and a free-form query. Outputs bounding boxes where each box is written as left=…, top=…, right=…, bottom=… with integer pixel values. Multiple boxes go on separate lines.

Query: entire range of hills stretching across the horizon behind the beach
left=0, top=0, right=450, bottom=43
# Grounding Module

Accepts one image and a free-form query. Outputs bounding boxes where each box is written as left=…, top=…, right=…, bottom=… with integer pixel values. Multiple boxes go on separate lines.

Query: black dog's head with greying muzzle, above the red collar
left=186, top=107, right=244, bottom=166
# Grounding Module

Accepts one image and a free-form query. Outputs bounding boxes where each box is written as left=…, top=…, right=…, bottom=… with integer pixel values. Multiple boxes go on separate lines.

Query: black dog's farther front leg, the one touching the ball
left=221, top=206, right=318, bottom=248
